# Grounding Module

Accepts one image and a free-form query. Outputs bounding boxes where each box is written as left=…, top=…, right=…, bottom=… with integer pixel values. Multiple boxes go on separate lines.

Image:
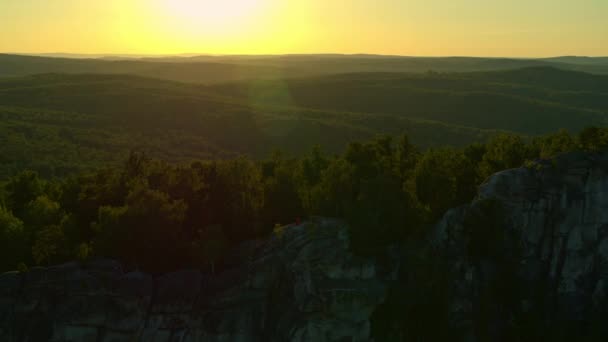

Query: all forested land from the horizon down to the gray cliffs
left=0, top=55, right=608, bottom=341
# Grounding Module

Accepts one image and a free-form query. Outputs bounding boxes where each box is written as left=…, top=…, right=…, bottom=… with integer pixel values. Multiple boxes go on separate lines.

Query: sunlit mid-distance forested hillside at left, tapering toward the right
left=0, top=74, right=494, bottom=177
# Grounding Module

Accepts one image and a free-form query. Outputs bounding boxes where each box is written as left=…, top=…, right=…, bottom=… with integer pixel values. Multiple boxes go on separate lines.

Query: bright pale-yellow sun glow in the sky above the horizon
left=142, top=0, right=306, bottom=54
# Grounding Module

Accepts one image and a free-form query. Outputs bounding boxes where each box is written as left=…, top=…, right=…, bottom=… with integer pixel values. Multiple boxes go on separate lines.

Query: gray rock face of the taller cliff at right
left=434, top=153, right=608, bottom=336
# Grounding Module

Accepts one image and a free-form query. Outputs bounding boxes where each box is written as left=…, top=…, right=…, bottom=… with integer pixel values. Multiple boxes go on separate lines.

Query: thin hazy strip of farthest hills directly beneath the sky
left=0, top=54, right=608, bottom=83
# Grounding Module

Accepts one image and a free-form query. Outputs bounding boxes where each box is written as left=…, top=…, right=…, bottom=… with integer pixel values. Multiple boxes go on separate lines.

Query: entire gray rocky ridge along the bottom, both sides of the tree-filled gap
left=5, top=153, right=608, bottom=342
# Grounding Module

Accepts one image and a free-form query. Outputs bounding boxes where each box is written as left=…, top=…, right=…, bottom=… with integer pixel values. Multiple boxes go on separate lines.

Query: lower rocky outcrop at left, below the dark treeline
left=0, top=220, right=385, bottom=342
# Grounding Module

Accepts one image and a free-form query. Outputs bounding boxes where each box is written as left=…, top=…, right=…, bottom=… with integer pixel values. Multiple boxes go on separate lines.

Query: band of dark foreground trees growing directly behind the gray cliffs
left=0, top=128, right=608, bottom=273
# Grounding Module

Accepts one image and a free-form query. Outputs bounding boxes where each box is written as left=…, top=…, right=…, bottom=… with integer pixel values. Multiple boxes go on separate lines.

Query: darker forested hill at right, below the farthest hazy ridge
left=212, top=67, right=608, bottom=134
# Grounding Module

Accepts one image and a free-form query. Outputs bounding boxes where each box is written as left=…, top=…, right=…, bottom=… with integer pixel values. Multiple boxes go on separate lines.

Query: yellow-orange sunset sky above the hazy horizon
left=0, top=0, right=608, bottom=57
